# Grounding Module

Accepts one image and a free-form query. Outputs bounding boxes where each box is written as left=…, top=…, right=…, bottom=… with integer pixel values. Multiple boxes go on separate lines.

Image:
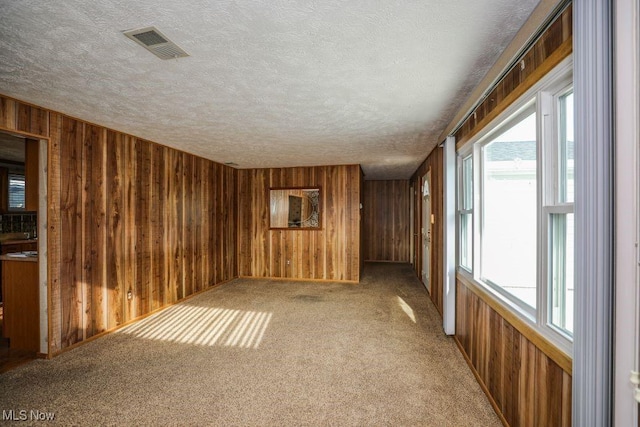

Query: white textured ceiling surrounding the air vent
left=0, top=0, right=538, bottom=179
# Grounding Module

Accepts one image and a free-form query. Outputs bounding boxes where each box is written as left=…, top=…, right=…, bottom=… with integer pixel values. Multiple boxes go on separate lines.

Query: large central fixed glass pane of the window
left=481, top=113, right=537, bottom=308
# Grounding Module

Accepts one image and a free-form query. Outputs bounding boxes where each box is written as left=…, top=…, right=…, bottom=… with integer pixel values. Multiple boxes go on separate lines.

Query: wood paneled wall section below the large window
left=456, top=281, right=571, bottom=427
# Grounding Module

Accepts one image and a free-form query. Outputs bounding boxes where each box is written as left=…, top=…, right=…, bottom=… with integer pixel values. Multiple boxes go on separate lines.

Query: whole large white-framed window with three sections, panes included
left=457, top=60, right=575, bottom=352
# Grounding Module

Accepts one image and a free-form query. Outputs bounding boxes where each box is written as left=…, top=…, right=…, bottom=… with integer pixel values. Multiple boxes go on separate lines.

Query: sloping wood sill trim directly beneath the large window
left=456, top=274, right=573, bottom=375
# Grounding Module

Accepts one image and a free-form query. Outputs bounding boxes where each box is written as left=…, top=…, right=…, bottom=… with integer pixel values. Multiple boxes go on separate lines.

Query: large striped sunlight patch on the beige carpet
left=118, top=304, right=273, bottom=349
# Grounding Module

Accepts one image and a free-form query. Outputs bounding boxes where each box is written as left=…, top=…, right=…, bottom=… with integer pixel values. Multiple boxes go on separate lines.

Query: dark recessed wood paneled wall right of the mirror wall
left=362, top=180, right=411, bottom=262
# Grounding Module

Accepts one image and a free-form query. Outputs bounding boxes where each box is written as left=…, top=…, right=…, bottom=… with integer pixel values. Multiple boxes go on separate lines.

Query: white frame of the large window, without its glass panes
left=456, top=56, right=575, bottom=356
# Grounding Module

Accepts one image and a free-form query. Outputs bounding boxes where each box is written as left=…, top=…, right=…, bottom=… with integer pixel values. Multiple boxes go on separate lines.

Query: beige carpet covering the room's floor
left=0, top=263, right=500, bottom=426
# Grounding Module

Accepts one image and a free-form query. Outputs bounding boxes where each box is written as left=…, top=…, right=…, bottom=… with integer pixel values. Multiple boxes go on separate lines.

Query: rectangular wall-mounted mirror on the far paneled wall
left=269, top=188, right=322, bottom=230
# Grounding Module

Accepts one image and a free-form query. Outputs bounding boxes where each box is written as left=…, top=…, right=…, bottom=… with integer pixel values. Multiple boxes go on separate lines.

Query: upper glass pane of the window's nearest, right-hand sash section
left=558, top=92, right=574, bottom=203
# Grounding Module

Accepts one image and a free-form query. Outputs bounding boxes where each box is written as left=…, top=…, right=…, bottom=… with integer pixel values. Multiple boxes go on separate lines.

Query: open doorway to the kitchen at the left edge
left=0, top=131, right=48, bottom=372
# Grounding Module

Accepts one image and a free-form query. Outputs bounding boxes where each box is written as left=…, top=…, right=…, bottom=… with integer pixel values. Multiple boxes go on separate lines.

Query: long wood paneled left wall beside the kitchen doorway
left=0, top=97, right=237, bottom=355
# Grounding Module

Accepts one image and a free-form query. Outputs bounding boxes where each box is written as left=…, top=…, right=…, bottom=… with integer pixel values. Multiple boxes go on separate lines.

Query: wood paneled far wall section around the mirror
left=238, top=165, right=361, bottom=282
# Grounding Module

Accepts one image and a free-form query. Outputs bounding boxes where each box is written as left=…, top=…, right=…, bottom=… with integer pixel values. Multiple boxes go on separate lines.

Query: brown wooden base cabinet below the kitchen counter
left=2, top=260, right=40, bottom=353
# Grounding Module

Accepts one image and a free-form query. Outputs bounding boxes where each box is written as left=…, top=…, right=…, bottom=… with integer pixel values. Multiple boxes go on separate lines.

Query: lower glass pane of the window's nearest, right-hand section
left=549, top=214, right=574, bottom=334
